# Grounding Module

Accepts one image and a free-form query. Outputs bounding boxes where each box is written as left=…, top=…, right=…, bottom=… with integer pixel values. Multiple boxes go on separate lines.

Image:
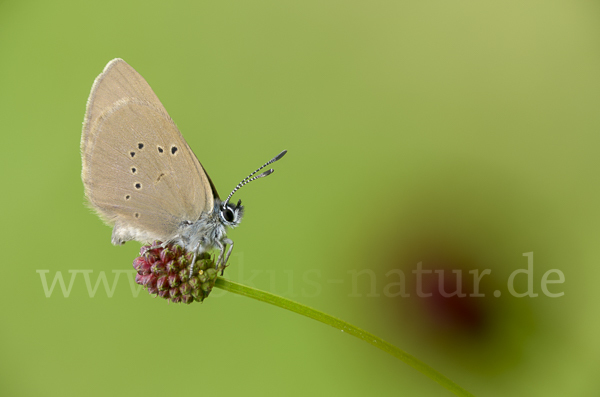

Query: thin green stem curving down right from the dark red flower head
left=215, top=277, right=474, bottom=397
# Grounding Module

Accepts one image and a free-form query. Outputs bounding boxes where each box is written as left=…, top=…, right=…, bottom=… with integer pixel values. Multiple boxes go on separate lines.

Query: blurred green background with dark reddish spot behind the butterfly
left=0, top=0, right=600, bottom=396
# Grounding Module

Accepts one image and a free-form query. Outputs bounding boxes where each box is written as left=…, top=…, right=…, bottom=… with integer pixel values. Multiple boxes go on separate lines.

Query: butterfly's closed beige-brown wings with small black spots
left=81, top=59, right=218, bottom=244
